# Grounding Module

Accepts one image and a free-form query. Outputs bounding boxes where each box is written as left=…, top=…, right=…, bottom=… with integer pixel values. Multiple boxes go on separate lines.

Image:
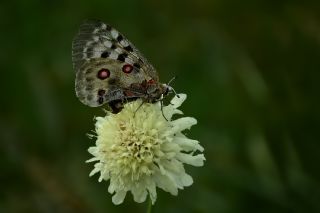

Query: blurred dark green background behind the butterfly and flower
left=0, top=0, right=320, bottom=213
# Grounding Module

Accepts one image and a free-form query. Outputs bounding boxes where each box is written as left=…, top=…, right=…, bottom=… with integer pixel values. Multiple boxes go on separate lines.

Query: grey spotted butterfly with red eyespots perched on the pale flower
left=72, top=20, right=173, bottom=113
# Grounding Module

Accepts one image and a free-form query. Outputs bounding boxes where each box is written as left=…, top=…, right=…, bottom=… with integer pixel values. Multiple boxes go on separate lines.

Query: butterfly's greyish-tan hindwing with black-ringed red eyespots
left=75, top=58, right=151, bottom=107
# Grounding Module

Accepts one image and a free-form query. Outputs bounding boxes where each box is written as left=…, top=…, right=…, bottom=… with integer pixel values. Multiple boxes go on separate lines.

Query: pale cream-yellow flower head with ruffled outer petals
left=87, top=94, right=205, bottom=204
